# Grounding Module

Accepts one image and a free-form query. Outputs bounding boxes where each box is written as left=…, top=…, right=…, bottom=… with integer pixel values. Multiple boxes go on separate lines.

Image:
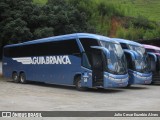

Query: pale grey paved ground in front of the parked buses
left=0, top=63, right=160, bottom=120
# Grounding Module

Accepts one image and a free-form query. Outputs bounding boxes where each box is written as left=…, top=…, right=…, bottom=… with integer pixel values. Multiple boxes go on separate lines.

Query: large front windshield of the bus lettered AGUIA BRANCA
left=101, top=41, right=127, bottom=74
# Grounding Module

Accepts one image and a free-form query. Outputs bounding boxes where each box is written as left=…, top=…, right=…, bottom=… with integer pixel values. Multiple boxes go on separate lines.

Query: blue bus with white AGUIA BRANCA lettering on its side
left=3, top=33, right=129, bottom=90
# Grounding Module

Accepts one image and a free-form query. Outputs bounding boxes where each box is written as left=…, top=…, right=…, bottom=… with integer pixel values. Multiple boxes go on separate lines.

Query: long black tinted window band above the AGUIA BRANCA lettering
left=4, top=40, right=80, bottom=57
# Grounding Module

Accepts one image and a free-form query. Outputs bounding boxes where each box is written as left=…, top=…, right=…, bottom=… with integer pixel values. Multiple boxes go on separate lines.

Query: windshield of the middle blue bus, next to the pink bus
left=129, top=45, right=150, bottom=72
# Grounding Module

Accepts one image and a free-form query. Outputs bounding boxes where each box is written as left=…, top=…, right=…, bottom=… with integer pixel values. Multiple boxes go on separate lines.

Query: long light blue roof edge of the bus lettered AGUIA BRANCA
left=5, top=33, right=118, bottom=47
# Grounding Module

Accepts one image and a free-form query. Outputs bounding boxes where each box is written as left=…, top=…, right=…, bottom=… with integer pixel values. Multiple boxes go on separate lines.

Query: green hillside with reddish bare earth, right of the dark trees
left=31, top=0, right=160, bottom=40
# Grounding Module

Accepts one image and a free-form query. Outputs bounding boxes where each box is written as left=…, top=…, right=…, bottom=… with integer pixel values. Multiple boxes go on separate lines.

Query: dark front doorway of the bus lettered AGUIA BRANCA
left=91, top=49, right=104, bottom=86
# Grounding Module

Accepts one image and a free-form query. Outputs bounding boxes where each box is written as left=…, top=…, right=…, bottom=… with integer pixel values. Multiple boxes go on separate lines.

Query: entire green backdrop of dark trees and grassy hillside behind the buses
left=0, top=0, right=160, bottom=58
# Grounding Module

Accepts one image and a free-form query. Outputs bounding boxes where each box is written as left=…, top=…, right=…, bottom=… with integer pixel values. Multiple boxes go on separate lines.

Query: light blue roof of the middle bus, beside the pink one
left=112, top=38, right=143, bottom=47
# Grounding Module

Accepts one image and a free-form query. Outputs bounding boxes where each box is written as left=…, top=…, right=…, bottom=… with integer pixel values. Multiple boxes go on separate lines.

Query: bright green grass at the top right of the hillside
left=94, top=0, right=160, bottom=22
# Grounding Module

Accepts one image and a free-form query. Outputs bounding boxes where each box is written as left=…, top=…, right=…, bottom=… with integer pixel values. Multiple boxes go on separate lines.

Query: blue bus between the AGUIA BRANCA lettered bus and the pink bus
left=113, top=38, right=156, bottom=87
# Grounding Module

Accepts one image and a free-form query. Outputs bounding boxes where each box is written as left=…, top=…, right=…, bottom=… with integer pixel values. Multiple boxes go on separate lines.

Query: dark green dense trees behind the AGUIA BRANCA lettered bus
left=0, top=0, right=92, bottom=46
